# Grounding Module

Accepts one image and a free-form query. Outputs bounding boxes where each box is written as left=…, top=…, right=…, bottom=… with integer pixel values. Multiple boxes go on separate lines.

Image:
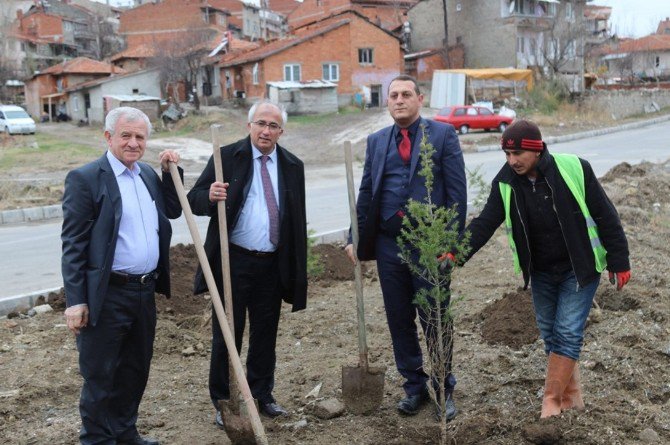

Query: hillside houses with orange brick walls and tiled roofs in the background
left=0, top=0, right=670, bottom=124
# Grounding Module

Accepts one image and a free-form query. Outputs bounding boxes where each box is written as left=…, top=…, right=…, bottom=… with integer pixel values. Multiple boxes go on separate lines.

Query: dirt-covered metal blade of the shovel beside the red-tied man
left=342, top=365, right=386, bottom=415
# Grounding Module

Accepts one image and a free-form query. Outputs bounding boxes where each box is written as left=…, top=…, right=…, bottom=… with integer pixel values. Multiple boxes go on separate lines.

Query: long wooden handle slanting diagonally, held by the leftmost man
left=169, top=158, right=268, bottom=445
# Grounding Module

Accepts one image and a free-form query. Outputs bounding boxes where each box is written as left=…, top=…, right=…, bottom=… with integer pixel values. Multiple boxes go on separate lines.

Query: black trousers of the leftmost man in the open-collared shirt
left=77, top=280, right=156, bottom=445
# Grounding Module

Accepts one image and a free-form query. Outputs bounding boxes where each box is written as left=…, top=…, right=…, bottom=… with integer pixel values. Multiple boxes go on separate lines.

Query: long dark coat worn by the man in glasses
left=188, top=136, right=307, bottom=312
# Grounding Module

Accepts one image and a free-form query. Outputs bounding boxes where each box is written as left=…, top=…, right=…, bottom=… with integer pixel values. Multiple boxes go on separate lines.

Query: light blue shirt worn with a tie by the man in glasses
left=230, top=144, right=279, bottom=252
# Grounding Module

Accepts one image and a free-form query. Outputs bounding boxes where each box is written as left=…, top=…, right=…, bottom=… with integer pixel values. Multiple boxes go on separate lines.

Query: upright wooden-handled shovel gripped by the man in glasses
left=211, top=125, right=254, bottom=445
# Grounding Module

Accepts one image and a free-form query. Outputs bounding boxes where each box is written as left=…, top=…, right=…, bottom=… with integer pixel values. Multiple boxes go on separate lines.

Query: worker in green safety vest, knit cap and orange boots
left=443, top=120, right=630, bottom=418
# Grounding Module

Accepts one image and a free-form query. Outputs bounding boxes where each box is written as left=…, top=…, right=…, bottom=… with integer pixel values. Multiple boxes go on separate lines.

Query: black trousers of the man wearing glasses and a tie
left=209, top=250, right=282, bottom=409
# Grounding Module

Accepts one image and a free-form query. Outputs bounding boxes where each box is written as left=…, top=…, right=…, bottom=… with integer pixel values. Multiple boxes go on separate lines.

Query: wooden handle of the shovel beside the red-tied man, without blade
left=344, top=141, right=368, bottom=369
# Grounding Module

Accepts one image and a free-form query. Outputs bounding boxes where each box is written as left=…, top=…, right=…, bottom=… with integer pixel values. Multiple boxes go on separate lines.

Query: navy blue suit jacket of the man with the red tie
left=356, top=118, right=467, bottom=261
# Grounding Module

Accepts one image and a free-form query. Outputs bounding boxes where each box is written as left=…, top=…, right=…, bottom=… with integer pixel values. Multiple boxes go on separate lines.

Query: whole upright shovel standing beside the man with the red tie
left=342, top=141, right=386, bottom=414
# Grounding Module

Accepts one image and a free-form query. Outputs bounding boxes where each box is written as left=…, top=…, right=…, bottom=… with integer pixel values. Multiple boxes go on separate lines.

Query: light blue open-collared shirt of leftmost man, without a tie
left=107, top=151, right=159, bottom=274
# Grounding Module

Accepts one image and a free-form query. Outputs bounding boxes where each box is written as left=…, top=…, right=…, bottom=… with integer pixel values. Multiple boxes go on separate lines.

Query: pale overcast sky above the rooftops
left=96, top=0, right=670, bottom=37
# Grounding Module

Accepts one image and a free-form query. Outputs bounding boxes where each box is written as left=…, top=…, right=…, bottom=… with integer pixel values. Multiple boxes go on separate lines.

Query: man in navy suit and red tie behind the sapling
left=346, top=75, right=467, bottom=419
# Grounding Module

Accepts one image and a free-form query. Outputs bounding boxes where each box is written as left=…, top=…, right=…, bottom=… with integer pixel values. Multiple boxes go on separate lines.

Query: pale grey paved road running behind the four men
left=0, top=122, right=670, bottom=300
